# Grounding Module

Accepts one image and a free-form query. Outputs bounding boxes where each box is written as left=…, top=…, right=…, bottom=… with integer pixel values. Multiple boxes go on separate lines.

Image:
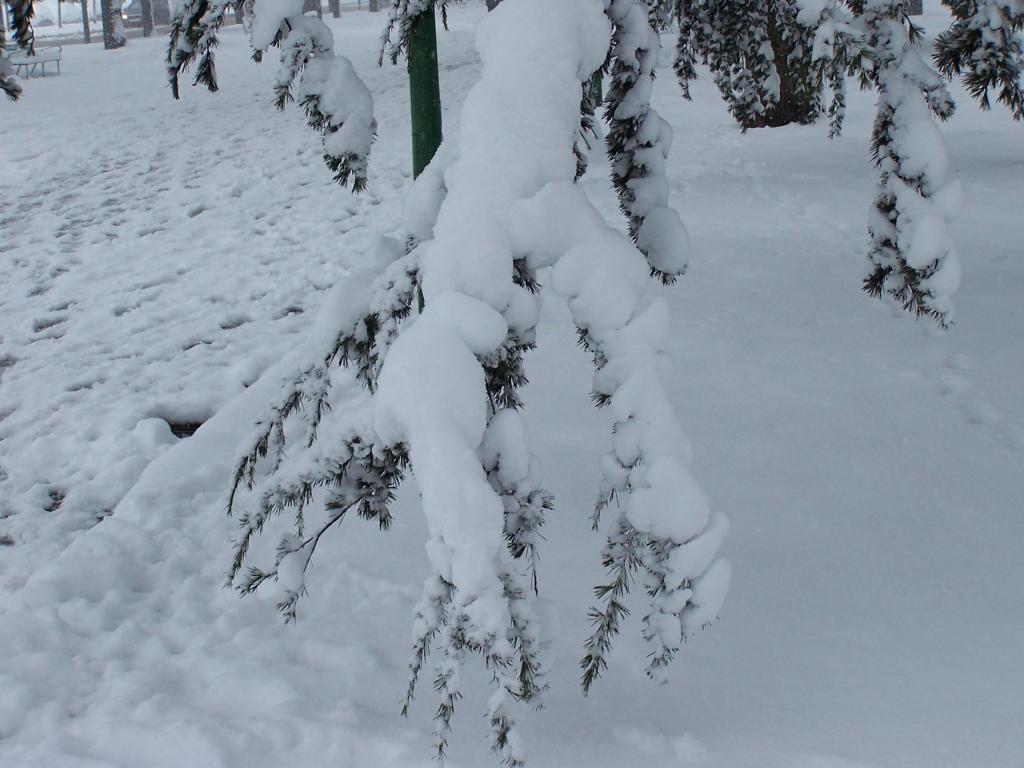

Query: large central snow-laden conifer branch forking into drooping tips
left=229, top=0, right=729, bottom=765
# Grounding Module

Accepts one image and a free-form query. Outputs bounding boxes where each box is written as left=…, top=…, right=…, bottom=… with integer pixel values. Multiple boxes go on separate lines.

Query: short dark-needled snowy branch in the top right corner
left=935, top=0, right=1024, bottom=120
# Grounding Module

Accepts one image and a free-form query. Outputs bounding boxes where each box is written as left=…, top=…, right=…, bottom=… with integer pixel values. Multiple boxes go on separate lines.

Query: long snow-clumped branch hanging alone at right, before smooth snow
left=851, top=0, right=961, bottom=328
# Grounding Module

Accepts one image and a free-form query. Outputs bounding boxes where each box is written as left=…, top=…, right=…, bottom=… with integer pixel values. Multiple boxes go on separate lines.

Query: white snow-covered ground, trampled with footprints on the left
left=0, top=3, right=1024, bottom=768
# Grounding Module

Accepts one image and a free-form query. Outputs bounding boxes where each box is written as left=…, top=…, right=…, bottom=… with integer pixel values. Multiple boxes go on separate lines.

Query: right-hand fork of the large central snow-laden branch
left=507, top=184, right=729, bottom=690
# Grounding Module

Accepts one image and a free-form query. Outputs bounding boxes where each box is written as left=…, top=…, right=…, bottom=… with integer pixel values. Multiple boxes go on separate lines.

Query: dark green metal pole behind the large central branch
left=409, top=8, right=441, bottom=178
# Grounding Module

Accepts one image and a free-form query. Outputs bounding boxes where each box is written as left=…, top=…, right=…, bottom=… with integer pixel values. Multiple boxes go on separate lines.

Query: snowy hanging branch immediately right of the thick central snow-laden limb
left=604, top=0, right=690, bottom=284
